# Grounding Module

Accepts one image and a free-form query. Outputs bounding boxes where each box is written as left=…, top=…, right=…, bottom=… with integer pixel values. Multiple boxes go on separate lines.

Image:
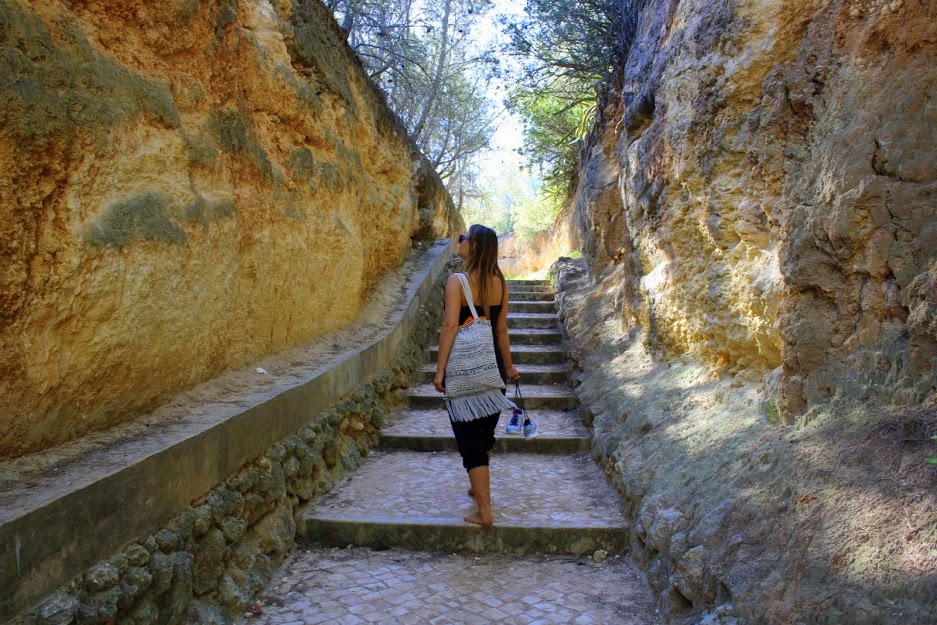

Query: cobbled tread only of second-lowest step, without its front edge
left=381, top=408, right=589, bottom=438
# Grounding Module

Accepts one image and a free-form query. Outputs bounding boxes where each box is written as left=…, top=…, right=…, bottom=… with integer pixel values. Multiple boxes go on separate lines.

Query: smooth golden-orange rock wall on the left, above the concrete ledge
left=0, top=0, right=461, bottom=458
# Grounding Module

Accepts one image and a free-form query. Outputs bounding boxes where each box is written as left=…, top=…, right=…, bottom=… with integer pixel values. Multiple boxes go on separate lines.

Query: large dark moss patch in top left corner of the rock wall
left=0, top=0, right=180, bottom=147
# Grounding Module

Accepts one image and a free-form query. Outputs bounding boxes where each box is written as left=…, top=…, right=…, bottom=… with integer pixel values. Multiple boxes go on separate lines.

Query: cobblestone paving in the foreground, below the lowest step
left=249, top=548, right=661, bottom=625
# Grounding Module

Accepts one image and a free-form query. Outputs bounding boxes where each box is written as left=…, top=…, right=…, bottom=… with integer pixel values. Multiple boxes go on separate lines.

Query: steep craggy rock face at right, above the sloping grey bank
left=572, top=0, right=937, bottom=422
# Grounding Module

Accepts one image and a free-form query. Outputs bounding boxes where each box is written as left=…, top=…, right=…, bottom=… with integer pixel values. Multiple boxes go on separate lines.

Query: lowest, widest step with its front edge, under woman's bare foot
left=297, top=451, right=627, bottom=555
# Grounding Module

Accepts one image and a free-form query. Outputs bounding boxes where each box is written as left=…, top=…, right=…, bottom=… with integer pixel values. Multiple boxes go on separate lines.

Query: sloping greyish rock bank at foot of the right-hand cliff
left=552, top=259, right=937, bottom=625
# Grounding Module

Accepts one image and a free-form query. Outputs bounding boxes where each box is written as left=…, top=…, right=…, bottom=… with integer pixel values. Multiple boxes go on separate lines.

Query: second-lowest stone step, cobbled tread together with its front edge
left=381, top=410, right=591, bottom=454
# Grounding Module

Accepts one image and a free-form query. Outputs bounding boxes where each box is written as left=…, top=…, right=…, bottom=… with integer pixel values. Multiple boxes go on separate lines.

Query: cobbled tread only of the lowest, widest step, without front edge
left=311, top=451, right=624, bottom=527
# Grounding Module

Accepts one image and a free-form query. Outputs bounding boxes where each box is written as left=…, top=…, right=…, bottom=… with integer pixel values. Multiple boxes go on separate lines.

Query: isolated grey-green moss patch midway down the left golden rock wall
left=84, top=191, right=186, bottom=248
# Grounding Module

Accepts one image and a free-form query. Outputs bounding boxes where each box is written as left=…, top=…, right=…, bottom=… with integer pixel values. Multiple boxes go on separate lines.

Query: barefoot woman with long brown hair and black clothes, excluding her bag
left=433, top=224, right=520, bottom=526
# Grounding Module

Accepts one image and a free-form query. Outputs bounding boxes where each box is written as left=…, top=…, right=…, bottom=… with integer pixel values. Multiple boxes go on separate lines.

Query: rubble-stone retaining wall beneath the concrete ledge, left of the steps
left=13, top=260, right=458, bottom=625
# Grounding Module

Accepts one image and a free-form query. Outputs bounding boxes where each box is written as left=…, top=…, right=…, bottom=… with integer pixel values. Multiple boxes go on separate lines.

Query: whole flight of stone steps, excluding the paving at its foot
left=297, top=280, right=626, bottom=555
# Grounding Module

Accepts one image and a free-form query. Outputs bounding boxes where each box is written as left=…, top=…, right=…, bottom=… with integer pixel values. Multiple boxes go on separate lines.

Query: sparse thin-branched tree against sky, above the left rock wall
left=325, top=0, right=497, bottom=191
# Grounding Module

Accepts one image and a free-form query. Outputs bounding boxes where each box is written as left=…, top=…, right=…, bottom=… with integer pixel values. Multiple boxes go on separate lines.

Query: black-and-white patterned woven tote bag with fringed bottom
left=445, top=273, right=515, bottom=421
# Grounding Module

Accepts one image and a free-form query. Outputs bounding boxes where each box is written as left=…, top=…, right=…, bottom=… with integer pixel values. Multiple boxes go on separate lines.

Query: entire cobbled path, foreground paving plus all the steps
left=250, top=281, right=660, bottom=625
